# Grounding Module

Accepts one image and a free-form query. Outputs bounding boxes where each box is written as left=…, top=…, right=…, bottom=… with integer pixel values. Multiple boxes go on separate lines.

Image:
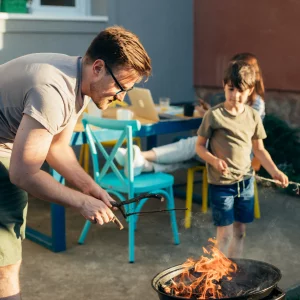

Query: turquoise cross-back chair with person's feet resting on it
left=78, top=114, right=180, bottom=263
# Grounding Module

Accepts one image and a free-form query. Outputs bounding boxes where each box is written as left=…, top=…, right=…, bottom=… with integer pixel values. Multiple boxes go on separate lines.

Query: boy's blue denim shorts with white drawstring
left=209, top=178, right=254, bottom=226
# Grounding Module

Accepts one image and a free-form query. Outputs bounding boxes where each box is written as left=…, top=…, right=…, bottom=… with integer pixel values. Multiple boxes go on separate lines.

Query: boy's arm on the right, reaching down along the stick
left=252, top=139, right=289, bottom=187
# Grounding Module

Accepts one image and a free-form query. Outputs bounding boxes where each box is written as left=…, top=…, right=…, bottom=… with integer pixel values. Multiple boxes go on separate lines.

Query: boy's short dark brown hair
left=223, top=60, right=256, bottom=91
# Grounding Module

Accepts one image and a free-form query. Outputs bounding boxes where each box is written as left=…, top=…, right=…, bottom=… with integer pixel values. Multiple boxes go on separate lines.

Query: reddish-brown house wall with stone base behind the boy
left=194, top=0, right=300, bottom=126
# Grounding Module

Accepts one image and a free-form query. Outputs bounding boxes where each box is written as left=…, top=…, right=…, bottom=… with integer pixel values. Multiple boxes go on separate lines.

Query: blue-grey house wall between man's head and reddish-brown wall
left=108, top=0, right=194, bottom=103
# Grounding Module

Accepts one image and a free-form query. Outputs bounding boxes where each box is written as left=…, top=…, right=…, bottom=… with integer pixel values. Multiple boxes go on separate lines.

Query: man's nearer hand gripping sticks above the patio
left=79, top=196, right=114, bottom=225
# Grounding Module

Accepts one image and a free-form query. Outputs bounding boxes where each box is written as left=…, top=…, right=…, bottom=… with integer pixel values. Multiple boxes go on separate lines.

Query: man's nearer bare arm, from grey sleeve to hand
left=9, top=115, right=114, bottom=224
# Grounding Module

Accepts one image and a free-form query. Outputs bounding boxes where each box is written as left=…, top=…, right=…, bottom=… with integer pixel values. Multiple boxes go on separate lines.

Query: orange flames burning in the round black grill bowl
left=164, top=239, right=237, bottom=299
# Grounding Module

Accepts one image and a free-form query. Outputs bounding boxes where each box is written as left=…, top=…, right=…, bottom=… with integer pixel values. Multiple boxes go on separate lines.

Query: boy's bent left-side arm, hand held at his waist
left=196, top=135, right=227, bottom=174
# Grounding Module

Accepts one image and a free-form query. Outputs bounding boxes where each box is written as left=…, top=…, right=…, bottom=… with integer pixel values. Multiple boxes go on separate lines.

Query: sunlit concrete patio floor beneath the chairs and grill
left=21, top=172, right=300, bottom=300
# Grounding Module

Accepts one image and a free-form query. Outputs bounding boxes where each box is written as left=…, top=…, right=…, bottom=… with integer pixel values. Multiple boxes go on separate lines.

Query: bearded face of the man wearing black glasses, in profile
left=88, top=61, right=140, bottom=110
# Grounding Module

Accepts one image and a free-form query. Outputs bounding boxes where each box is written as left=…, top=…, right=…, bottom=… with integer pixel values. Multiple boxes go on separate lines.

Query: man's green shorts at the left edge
left=0, top=157, right=28, bottom=267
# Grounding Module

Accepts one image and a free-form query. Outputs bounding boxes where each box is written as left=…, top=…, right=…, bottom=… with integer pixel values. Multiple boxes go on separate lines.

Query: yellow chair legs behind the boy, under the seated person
left=184, top=166, right=260, bottom=228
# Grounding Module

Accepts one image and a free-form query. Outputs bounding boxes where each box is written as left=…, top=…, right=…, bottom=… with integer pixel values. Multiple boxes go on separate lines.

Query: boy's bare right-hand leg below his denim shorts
left=228, top=222, right=246, bottom=258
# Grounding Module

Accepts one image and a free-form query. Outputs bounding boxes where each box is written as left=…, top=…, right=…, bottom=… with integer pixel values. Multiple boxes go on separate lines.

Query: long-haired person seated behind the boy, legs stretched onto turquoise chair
left=116, top=53, right=265, bottom=176
